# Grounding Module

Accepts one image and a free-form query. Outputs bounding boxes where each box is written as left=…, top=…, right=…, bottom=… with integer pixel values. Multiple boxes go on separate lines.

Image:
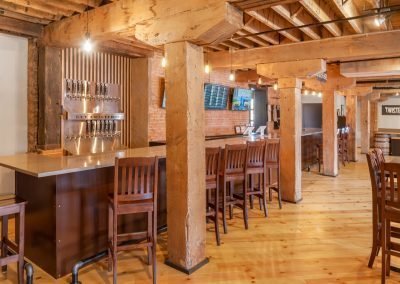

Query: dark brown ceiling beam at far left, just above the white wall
left=0, top=16, right=42, bottom=37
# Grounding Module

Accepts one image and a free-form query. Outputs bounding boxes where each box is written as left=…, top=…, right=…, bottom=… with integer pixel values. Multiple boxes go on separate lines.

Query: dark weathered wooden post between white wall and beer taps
left=38, top=46, right=62, bottom=150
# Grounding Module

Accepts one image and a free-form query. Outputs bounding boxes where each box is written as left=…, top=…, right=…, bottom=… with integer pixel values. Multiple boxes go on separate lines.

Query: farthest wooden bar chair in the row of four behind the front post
left=265, top=140, right=282, bottom=209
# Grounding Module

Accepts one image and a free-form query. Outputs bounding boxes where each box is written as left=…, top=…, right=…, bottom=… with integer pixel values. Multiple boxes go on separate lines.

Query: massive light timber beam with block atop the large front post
left=41, top=0, right=243, bottom=46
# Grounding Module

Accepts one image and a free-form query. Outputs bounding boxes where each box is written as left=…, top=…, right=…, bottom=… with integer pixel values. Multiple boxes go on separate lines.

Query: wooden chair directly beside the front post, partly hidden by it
left=206, top=147, right=221, bottom=245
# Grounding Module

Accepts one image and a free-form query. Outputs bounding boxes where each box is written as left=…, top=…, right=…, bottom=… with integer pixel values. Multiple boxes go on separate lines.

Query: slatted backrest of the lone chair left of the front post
left=114, top=157, right=158, bottom=202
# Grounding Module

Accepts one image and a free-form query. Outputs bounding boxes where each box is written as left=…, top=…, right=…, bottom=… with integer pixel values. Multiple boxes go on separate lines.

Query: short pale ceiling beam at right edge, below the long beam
left=340, top=58, right=400, bottom=78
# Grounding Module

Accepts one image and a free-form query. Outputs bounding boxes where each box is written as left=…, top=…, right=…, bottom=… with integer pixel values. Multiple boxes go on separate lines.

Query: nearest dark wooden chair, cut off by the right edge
left=380, top=163, right=400, bottom=283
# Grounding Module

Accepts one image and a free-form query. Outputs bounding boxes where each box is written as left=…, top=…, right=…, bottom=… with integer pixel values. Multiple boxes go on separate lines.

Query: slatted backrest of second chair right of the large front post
left=223, top=144, right=247, bottom=174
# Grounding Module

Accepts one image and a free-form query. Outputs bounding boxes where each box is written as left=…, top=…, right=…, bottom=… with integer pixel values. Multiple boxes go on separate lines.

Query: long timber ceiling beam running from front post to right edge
left=209, top=30, right=400, bottom=69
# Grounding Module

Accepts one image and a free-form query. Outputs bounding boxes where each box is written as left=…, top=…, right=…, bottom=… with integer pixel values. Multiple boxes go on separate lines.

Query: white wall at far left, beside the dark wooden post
left=0, top=33, right=28, bottom=194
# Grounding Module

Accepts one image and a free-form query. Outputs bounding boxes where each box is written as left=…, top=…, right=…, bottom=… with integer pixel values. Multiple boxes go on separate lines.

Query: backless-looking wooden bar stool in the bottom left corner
left=0, top=195, right=27, bottom=284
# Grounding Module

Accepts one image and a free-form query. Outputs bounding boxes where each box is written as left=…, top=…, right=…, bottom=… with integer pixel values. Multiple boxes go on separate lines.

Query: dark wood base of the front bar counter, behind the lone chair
left=15, top=159, right=167, bottom=278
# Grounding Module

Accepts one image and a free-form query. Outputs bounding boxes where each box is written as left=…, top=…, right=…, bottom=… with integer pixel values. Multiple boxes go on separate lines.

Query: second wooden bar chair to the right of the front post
left=220, top=144, right=248, bottom=234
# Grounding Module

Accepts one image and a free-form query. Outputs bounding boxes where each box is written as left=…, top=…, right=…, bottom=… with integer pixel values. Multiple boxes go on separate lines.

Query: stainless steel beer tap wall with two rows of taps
left=62, top=79, right=125, bottom=155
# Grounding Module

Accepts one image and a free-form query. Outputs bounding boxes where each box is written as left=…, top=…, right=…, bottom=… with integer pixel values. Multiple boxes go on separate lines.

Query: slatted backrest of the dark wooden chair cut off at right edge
left=380, top=163, right=400, bottom=209
